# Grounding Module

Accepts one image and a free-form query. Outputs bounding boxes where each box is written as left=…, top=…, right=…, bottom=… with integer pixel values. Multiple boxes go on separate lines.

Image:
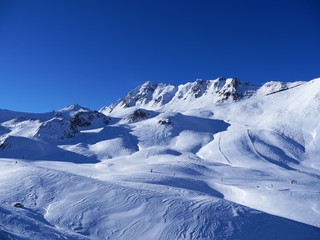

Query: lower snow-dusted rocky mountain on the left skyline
left=0, top=104, right=111, bottom=142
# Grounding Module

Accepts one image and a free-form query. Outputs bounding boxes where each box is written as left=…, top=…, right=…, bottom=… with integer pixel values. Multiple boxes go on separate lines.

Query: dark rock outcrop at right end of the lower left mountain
left=71, top=111, right=111, bottom=127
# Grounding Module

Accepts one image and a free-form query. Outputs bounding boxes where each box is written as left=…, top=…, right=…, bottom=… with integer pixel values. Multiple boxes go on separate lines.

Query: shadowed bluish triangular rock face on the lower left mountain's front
left=35, top=118, right=79, bottom=139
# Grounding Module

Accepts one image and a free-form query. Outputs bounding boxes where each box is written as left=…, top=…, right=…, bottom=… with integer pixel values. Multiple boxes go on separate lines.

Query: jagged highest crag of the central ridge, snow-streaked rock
left=100, top=78, right=253, bottom=113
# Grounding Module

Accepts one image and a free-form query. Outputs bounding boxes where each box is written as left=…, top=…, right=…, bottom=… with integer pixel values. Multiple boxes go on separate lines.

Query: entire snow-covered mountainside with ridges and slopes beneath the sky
left=0, top=78, right=320, bottom=240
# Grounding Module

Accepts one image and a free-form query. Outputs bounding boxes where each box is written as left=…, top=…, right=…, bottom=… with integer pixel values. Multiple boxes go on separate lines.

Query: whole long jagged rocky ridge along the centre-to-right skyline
left=100, top=78, right=303, bottom=114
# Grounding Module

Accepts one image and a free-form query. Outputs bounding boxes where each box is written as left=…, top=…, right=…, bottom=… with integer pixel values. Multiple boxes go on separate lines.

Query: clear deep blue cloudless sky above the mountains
left=0, top=0, right=320, bottom=112
